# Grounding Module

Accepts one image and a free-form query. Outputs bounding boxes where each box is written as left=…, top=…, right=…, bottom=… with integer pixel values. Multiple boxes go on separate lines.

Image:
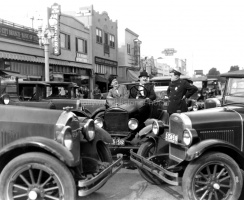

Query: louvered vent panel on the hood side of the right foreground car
left=199, top=130, right=234, bottom=144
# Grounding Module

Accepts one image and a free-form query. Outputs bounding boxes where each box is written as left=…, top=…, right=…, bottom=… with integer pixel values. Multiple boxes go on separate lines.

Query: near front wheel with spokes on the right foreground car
left=182, top=152, right=243, bottom=200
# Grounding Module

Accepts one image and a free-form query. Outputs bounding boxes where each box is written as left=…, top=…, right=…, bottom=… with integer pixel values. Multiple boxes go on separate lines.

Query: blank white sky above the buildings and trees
left=0, top=0, right=244, bottom=74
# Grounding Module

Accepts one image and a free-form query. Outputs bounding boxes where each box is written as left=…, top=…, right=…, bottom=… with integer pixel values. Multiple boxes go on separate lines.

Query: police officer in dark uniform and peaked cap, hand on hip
left=167, top=69, right=197, bottom=115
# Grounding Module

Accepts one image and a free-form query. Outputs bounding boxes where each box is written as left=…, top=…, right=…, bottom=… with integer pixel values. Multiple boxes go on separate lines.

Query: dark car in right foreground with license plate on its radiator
left=131, top=70, right=244, bottom=200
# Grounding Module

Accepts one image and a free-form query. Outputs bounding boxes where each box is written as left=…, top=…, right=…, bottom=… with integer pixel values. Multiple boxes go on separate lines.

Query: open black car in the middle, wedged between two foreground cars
left=94, top=83, right=168, bottom=158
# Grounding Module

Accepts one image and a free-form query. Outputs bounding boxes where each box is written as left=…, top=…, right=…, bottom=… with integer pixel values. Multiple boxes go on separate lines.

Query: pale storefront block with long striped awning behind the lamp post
left=0, top=7, right=93, bottom=92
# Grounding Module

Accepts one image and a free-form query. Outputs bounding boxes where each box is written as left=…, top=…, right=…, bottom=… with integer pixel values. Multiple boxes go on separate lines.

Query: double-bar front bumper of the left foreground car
left=78, top=157, right=123, bottom=196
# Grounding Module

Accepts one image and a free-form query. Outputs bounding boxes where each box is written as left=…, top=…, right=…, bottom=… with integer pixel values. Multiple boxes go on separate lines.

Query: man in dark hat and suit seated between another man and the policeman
left=133, top=71, right=156, bottom=100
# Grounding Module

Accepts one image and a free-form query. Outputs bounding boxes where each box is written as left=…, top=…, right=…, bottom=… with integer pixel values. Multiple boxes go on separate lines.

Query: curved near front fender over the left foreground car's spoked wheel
left=0, top=137, right=80, bottom=167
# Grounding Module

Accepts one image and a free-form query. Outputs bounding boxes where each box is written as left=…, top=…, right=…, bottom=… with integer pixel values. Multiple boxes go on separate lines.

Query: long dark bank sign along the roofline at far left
left=0, top=21, right=39, bottom=44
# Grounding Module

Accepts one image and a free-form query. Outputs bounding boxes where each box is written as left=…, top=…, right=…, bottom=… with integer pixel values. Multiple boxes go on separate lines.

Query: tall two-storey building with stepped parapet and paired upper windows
left=66, top=5, right=118, bottom=92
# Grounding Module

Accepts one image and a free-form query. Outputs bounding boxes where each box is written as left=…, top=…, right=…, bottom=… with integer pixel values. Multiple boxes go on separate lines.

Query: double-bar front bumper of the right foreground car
left=130, top=150, right=181, bottom=185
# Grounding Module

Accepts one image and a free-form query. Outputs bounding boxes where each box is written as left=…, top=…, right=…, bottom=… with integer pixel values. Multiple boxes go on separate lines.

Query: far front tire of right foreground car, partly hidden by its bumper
left=137, top=140, right=164, bottom=185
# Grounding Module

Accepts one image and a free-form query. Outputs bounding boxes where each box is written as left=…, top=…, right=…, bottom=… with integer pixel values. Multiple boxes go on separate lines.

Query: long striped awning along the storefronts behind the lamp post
left=0, top=51, right=93, bottom=69
